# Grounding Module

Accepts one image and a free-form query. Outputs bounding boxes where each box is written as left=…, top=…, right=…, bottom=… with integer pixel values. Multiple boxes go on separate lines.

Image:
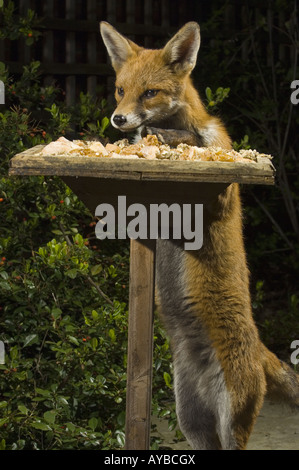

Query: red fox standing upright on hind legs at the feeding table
left=101, top=22, right=299, bottom=450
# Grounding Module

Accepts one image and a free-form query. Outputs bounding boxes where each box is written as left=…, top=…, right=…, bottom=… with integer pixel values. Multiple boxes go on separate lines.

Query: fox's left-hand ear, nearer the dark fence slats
left=100, top=21, right=142, bottom=72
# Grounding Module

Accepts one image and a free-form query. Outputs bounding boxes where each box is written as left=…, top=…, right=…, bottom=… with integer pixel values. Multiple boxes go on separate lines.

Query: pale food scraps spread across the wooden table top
left=41, top=135, right=272, bottom=162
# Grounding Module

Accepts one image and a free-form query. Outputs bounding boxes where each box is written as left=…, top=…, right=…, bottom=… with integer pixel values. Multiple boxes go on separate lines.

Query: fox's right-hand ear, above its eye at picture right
left=163, top=21, right=200, bottom=73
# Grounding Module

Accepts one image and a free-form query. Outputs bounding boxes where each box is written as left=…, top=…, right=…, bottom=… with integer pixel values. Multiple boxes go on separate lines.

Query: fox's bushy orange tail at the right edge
left=262, top=345, right=299, bottom=409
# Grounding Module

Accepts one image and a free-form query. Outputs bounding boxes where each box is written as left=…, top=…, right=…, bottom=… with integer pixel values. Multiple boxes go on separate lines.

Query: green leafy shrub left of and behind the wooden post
left=0, top=2, right=171, bottom=450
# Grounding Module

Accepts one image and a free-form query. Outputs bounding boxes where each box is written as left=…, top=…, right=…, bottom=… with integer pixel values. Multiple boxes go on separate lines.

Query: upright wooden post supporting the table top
left=125, top=240, right=156, bottom=450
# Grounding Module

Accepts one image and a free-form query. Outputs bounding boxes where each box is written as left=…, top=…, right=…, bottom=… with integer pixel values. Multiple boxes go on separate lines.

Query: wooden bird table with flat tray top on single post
left=9, top=145, right=275, bottom=450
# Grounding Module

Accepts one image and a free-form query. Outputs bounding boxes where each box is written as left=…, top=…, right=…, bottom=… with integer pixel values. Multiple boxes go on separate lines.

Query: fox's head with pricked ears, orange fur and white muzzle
left=100, top=22, right=200, bottom=132
